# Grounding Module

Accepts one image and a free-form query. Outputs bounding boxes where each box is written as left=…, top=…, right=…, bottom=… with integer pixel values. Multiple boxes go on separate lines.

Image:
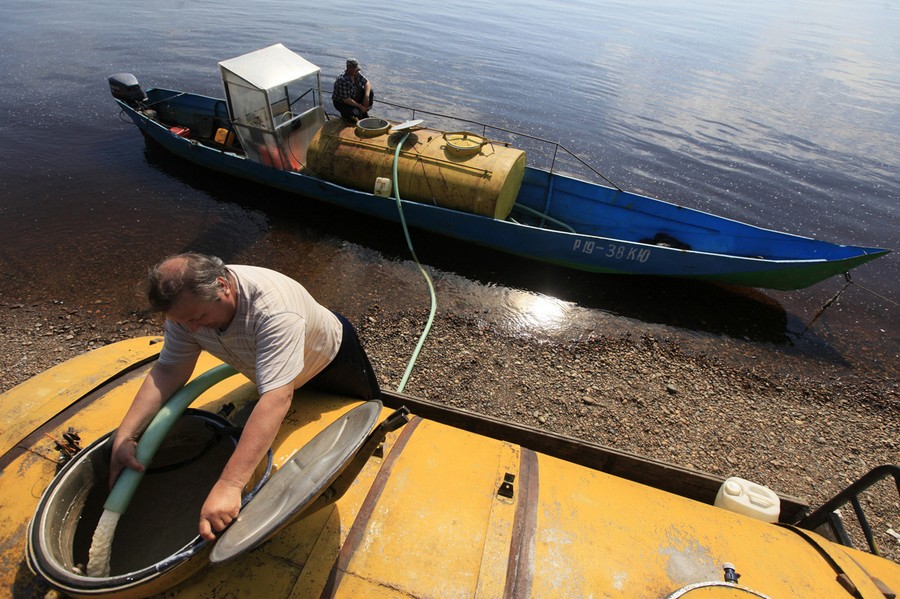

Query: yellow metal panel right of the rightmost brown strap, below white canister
left=533, top=456, right=892, bottom=597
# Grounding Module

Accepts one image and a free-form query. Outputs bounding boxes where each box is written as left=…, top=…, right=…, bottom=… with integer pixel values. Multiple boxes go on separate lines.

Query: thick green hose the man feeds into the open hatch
left=103, top=364, right=237, bottom=514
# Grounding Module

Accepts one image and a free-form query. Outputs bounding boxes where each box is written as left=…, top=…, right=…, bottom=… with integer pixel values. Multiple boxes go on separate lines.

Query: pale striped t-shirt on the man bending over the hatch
left=159, top=265, right=343, bottom=394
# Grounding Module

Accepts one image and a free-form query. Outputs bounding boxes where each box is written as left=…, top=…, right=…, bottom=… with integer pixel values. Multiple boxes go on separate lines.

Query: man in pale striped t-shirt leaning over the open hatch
left=110, top=254, right=381, bottom=540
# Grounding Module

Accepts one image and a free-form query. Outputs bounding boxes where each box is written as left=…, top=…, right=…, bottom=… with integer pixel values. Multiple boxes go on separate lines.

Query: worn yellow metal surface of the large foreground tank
left=0, top=345, right=900, bottom=599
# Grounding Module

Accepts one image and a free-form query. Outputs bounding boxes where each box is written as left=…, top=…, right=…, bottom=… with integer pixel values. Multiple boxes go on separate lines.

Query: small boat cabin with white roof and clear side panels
left=219, top=44, right=325, bottom=170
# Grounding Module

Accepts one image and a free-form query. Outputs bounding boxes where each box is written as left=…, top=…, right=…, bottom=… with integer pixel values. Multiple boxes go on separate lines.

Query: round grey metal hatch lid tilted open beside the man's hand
left=209, top=400, right=381, bottom=564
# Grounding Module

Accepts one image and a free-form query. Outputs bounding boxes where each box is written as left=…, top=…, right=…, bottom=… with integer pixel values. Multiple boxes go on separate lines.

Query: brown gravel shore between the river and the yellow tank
left=0, top=301, right=900, bottom=562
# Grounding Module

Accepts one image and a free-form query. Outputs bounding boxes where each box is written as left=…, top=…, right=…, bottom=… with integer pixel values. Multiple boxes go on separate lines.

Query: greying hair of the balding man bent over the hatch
left=147, top=253, right=230, bottom=312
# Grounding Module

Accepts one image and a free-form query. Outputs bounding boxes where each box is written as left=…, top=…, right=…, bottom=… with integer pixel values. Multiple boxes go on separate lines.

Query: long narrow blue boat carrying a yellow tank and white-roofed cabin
left=109, top=44, right=890, bottom=290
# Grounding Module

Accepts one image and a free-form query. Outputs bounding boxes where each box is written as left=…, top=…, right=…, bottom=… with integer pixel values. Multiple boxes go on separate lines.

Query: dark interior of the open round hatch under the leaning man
left=37, top=411, right=235, bottom=577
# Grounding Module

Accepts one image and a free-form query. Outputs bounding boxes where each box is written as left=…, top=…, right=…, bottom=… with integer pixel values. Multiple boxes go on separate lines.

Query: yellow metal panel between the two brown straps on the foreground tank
left=339, top=421, right=511, bottom=597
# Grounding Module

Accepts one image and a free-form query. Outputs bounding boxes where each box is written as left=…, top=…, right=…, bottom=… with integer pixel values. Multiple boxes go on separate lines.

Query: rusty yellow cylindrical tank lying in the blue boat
left=307, top=118, right=525, bottom=219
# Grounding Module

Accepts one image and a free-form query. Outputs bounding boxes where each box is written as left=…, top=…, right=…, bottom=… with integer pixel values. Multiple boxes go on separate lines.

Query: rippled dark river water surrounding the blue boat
left=0, top=0, right=900, bottom=377
